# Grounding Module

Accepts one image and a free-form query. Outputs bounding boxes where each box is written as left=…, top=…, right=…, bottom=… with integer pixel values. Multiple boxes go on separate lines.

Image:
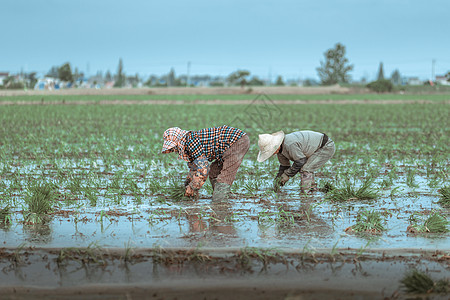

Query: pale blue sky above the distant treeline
left=0, top=0, right=450, bottom=80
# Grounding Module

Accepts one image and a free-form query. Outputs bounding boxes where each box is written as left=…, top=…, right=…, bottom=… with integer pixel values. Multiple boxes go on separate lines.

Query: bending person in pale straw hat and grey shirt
left=257, top=130, right=335, bottom=192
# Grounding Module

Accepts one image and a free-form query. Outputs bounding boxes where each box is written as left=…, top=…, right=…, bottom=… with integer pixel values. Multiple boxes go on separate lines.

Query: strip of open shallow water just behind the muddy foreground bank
left=0, top=185, right=450, bottom=252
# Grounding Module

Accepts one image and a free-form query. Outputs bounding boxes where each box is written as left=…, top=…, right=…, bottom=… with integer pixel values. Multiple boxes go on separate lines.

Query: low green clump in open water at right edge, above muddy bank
left=406, top=211, right=450, bottom=233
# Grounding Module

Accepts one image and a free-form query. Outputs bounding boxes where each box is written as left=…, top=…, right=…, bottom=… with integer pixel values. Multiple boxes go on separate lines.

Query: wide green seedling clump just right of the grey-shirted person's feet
left=327, top=178, right=378, bottom=201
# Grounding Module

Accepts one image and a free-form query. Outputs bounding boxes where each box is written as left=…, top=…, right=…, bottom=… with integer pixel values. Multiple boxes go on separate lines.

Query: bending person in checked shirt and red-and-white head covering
left=161, top=125, right=250, bottom=202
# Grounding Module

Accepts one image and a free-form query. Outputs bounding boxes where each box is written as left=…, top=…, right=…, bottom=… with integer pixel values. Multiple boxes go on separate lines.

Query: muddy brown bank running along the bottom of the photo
left=0, top=247, right=450, bottom=299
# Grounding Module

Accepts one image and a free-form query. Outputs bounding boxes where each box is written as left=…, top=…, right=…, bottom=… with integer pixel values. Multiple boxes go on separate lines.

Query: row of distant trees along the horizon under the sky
left=3, top=43, right=450, bottom=92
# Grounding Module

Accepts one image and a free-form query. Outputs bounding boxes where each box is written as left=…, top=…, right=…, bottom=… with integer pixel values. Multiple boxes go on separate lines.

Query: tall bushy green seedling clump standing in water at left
left=24, top=182, right=58, bottom=223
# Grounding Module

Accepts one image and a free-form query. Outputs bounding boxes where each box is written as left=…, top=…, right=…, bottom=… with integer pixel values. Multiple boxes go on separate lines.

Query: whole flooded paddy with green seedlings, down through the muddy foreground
left=0, top=104, right=450, bottom=299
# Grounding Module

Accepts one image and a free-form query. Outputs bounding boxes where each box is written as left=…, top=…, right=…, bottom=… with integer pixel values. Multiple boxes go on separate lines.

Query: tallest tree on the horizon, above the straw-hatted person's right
left=316, top=43, right=353, bottom=85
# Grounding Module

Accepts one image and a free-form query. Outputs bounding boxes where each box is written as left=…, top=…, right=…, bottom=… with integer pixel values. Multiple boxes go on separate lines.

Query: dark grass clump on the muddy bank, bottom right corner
left=400, top=270, right=450, bottom=294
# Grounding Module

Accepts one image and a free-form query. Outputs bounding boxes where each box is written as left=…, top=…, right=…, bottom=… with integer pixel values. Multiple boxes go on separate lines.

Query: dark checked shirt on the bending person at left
left=183, top=125, right=245, bottom=162
